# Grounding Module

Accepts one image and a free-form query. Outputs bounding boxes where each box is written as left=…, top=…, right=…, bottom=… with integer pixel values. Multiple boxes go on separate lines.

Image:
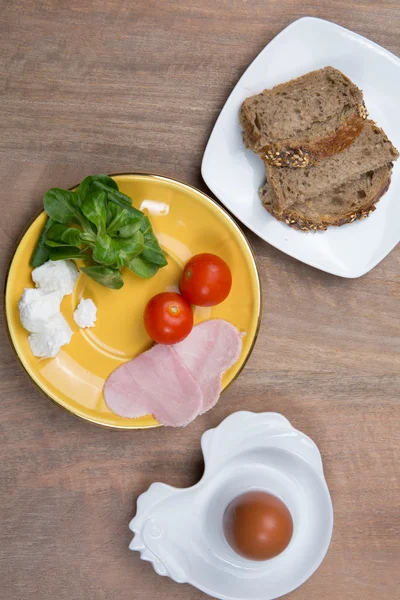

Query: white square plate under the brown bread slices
left=202, top=17, right=400, bottom=277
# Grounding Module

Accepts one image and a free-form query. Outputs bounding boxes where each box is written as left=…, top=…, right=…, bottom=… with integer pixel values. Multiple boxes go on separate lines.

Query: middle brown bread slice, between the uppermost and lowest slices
left=265, top=121, right=398, bottom=212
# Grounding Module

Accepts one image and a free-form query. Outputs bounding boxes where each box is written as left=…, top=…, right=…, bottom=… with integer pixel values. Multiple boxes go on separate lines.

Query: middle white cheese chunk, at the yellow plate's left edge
left=18, top=288, right=62, bottom=333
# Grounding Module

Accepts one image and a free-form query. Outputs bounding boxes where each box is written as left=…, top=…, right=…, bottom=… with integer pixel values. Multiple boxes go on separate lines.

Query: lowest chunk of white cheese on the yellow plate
left=28, top=312, right=72, bottom=358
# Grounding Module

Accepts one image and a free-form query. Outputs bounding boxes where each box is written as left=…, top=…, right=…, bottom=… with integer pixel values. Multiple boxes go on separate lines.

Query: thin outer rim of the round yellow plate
left=3, top=172, right=263, bottom=431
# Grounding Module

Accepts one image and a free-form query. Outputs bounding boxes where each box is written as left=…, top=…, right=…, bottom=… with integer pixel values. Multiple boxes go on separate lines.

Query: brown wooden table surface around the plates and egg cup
left=0, top=0, right=400, bottom=600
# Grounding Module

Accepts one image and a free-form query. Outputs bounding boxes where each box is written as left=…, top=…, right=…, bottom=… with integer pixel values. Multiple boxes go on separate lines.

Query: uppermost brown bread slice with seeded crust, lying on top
left=240, top=67, right=367, bottom=168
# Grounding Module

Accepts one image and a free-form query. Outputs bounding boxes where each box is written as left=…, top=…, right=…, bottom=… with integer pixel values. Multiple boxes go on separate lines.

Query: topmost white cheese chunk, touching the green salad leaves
left=32, top=260, right=79, bottom=296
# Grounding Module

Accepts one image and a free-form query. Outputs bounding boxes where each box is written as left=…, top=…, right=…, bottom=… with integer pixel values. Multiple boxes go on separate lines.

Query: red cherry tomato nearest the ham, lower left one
left=144, top=292, right=193, bottom=344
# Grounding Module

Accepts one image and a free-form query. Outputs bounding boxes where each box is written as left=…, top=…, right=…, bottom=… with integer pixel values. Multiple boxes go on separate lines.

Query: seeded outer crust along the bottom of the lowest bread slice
left=260, top=165, right=392, bottom=232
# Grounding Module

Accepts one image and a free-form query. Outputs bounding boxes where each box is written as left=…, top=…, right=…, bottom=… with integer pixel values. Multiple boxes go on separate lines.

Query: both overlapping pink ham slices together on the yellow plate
left=104, top=319, right=242, bottom=427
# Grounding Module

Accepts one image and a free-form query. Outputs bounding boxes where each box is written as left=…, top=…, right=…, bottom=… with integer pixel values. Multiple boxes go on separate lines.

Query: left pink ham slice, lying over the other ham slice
left=104, top=345, right=203, bottom=427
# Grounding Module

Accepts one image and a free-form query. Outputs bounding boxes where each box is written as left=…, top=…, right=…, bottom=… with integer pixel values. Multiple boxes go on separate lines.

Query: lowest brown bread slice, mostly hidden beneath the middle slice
left=260, top=163, right=392, bottom=231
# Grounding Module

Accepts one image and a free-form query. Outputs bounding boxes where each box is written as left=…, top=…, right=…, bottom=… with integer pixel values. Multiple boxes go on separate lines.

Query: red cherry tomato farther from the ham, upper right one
left=180, top=253, right=232, bottom=306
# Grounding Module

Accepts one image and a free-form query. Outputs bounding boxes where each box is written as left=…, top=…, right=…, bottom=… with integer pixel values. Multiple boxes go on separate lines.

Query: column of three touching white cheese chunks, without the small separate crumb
left=18, top=260, right=79, bottom=358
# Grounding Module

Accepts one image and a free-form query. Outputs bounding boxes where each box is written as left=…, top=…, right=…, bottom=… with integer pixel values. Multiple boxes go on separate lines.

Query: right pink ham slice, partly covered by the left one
left=172, top=319, right=242, bottom=414
